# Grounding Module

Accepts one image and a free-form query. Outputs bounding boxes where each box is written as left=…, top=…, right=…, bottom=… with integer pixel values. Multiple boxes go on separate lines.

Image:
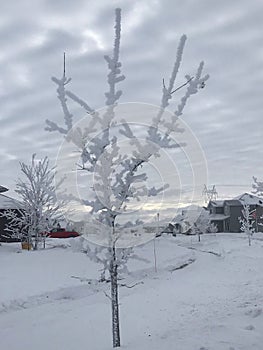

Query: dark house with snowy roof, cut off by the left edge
left=0, top=186, right=20, bottom=242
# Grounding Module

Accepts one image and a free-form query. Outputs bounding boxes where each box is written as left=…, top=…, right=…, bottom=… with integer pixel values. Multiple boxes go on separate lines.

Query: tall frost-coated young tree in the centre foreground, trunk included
left=46, top=9, right=208, bottom=347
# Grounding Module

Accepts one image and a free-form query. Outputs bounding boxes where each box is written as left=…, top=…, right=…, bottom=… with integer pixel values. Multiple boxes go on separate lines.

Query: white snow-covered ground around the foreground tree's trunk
left=0, top=233, right=263, bottom=350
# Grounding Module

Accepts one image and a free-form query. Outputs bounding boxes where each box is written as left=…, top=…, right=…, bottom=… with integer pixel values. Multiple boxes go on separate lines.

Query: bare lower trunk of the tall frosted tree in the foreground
left=110, top=247, right=121, bottom=348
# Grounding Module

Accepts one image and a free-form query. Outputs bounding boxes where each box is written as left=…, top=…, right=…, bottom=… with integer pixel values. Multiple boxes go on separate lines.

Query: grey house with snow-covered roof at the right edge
left=207, top=193, right=263, bottom=232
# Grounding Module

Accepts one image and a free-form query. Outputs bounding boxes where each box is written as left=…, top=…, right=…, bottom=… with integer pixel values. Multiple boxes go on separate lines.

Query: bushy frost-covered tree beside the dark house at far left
left=2, top=154, right=63, bottom=250
